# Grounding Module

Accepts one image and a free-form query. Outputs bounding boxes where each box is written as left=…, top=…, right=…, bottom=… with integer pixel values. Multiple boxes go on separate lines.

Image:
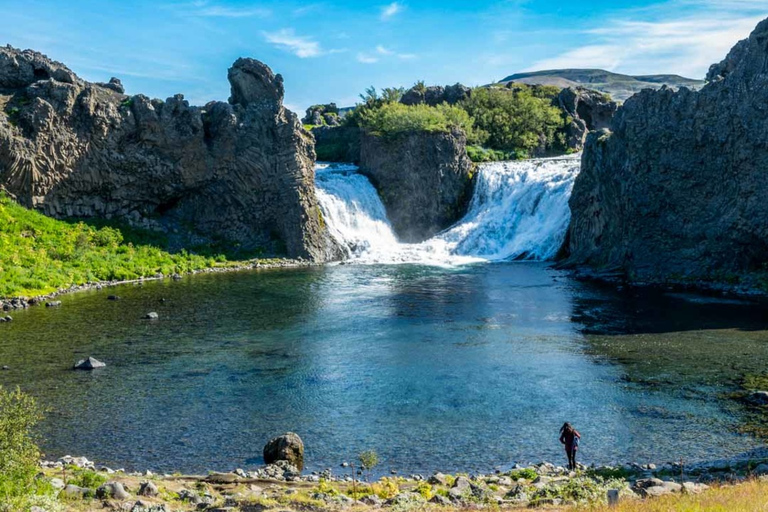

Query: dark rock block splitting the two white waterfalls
left=360, top=130, right=473, bottom=242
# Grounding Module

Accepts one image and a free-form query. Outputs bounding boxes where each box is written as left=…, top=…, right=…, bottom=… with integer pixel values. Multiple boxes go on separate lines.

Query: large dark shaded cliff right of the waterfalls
left=567, top=20, right=768, bottom=281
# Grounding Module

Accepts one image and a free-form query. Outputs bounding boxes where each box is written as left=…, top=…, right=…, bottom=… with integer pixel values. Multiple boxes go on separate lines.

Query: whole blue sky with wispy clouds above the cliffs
left=0, top=0, right=768, bottom=110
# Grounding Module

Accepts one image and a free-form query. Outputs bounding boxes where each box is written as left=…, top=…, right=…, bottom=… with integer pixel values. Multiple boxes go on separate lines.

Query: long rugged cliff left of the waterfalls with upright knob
left=0, top=47, right=331, bottom=260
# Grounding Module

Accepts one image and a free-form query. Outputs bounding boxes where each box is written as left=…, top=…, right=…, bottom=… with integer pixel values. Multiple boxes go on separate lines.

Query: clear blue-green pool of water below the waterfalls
left=0, top=263, right=768, bottom=473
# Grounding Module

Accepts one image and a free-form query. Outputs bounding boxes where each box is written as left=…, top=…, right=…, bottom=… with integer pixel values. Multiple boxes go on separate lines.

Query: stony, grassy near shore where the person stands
left=27, top=453, right=768, bottom=512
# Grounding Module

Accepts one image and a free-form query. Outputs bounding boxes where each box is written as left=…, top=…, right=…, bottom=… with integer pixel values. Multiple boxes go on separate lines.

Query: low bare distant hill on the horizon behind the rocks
left=500, top=69, right=705, bottom=101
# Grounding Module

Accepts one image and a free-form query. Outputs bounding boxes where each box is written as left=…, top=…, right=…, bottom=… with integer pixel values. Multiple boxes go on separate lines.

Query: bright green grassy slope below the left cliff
left=0, top=194, right=255, bottom=297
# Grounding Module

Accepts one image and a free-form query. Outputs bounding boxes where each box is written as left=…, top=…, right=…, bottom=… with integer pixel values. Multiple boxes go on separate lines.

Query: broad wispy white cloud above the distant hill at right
left=527, top=10, right=764, bottom=78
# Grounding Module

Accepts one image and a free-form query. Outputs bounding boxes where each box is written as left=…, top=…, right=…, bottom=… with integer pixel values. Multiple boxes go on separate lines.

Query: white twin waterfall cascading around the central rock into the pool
left=316, top=155, right=580, bottom=266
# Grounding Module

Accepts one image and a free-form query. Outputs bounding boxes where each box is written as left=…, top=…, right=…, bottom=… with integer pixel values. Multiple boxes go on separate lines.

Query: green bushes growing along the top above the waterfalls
left=316, top=82, right=570, bottom=162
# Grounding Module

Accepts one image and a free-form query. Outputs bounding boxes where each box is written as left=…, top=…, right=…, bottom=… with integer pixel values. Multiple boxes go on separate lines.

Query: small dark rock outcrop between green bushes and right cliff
left=554, top=87, right=619, bottom=151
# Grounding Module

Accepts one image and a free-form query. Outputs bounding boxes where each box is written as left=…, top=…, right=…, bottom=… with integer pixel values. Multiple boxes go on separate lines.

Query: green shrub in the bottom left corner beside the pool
left=0, top=387, right=43, bottom=504
